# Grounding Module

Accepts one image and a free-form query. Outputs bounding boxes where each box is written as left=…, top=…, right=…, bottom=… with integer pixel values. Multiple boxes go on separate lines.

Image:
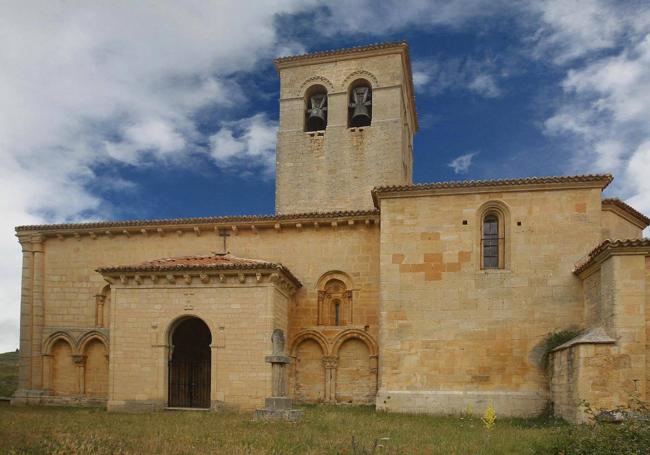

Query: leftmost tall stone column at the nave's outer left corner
left=16, top=234, right=33, bottom=395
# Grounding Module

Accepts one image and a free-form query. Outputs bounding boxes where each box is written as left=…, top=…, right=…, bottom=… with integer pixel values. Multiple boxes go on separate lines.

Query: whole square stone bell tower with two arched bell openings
left=275, top=43, right=418, bottom=214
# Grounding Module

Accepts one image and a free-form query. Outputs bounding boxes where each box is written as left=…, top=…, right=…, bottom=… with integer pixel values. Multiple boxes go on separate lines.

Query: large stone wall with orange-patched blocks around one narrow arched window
left=377, top=189, right=601, bottom=415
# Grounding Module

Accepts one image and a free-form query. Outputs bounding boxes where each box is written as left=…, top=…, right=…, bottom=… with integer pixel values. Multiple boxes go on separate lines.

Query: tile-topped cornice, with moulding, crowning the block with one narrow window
left=372, top=174, right=613, bottom=208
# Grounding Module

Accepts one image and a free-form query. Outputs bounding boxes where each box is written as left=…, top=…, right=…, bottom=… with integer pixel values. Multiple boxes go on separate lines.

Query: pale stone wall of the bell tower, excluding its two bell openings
left=276, top=54, right=413, bottom=213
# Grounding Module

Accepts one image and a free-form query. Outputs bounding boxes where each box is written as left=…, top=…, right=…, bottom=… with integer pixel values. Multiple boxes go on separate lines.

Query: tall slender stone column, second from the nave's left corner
left=31, top=234, right=45, bottom=389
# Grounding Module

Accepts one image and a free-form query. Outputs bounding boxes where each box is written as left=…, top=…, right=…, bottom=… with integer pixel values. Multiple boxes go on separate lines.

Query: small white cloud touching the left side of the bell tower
left=210, top=114, right=278, bottom=176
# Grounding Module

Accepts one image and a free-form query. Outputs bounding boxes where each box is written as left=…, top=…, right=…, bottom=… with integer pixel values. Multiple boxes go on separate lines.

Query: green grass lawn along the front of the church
left=0, top=406, right=564, bottom=455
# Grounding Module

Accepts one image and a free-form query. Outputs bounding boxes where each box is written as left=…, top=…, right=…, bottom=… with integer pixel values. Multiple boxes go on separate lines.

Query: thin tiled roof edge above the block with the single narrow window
left=372, top=174, right=614, bottom=194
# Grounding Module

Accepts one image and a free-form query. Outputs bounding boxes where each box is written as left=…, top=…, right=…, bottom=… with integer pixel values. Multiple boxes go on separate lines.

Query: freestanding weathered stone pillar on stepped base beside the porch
left=255, top=329, right=302, bottom=422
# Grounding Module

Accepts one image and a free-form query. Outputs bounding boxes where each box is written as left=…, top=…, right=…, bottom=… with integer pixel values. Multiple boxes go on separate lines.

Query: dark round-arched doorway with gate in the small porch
left=169, top=317, right=212, bottom=408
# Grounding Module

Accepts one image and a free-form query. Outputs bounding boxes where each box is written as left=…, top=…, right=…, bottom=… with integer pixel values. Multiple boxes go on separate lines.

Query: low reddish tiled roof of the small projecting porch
left=96, top=253, right=302, bottom=287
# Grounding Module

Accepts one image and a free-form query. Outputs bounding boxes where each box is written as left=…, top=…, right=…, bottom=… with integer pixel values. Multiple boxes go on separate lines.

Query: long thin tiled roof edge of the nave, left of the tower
left=16, top=210, right=379, bottom=231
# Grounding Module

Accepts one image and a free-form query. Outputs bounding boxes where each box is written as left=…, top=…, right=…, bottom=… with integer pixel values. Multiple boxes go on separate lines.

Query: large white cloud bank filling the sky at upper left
left=0, top=0, right=308, bottom=351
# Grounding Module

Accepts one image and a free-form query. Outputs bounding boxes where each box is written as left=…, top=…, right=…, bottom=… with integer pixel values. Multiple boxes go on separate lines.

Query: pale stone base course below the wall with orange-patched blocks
left=377, top=390, right=549, bottom=417
